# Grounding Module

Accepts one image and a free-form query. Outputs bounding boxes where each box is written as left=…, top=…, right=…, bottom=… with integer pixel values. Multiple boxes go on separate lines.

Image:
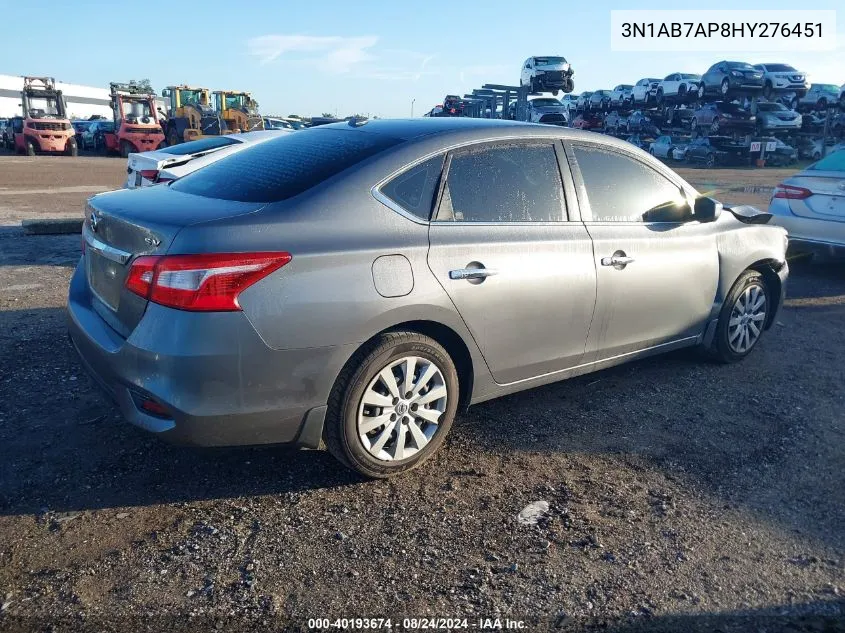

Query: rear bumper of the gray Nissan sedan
left=67, top=266, right=351, bottom=448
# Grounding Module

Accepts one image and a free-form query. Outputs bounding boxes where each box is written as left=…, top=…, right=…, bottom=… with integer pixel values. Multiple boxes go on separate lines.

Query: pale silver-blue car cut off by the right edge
left=769, top=149, right=845, bottom=257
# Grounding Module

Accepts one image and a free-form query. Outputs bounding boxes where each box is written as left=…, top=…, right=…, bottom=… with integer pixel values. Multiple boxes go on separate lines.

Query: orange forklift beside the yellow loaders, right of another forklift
left=103, top=82, right=164, bottom=158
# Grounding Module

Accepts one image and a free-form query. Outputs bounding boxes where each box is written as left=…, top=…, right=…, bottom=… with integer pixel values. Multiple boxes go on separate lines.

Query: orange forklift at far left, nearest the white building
left=9, top=77, right=78, bottom=156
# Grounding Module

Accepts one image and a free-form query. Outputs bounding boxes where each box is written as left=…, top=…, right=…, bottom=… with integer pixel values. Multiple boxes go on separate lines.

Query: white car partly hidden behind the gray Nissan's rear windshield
left=123, top=129, right=293, bottom=189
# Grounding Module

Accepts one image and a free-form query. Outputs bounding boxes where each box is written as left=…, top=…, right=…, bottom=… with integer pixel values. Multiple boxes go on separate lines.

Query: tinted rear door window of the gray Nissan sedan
left=437, top=142, right=565, bottom=222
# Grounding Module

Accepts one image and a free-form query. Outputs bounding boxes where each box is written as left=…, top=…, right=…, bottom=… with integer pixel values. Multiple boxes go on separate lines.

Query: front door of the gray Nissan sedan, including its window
left=566, top=141, right=719, bottom=362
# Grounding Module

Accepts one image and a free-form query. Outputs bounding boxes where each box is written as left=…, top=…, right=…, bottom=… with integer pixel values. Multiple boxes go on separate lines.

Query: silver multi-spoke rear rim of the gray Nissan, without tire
left=358, top=356, right=448, bottom=461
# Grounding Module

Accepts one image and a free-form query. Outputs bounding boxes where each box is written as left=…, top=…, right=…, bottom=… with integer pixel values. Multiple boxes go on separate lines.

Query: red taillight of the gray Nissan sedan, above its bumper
left=126, top=253, right=291, bottom=312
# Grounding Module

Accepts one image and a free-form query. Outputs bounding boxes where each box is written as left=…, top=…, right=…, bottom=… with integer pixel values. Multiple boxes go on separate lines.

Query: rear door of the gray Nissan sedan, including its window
left=428, top=139, right=596, bottom=384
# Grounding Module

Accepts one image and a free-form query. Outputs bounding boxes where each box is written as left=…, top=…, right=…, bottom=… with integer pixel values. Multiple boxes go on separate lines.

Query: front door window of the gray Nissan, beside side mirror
left=573, top=145, right=692, bottom=222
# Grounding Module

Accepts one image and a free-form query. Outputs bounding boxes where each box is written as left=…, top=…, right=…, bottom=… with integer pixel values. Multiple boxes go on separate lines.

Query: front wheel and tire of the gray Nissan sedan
left=706, top=270, right=772, bottom=363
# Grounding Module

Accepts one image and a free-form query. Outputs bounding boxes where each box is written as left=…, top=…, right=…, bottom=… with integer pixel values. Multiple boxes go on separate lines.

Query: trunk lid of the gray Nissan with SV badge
left=82, top=185, right=265, bottom=337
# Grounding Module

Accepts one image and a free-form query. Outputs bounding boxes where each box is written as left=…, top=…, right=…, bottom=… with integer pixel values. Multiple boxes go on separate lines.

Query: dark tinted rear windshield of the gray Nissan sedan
left=171, top=128, right=402, bottom=202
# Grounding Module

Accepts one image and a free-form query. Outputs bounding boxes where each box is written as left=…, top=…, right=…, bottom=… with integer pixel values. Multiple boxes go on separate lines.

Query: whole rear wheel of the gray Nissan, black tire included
left=323, top=332, right=460, bottom=478
